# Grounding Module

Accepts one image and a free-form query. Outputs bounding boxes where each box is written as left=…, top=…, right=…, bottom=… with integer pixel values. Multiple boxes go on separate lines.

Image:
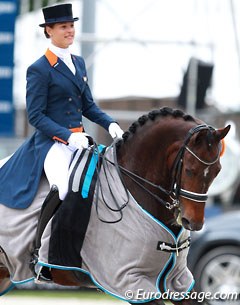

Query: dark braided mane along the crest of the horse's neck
left=117, top=107, right=196, bottom=147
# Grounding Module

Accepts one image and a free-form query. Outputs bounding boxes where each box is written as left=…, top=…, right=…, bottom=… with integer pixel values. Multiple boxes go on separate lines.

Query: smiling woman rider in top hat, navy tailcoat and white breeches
left=0, top=4, right=123, bottom=208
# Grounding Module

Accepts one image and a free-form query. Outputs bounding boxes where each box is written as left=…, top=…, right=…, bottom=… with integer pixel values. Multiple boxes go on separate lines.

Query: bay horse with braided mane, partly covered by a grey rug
left=0, top=107, right=230, bottom=305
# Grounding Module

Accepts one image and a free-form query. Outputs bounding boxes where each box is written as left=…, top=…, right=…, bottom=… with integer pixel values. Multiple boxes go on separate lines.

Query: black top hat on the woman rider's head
left=39, top=3, right=79, bottom=27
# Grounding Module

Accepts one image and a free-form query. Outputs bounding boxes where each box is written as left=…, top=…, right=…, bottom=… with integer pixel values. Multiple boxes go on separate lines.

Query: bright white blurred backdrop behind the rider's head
left=14, top=0, right=240, bottom=110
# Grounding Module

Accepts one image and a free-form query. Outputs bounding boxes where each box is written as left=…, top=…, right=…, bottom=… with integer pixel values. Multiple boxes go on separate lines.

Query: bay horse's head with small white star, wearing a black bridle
left=168, top=124, right=230, bottom=231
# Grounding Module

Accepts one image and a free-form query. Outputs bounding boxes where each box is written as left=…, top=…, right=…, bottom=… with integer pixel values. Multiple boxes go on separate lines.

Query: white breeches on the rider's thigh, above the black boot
left=44, top=142, right=80, bottom=200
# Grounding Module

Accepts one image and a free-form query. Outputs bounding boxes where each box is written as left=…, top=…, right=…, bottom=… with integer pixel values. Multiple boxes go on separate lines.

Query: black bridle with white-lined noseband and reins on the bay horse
left=114, top=124, right=221, bottom=210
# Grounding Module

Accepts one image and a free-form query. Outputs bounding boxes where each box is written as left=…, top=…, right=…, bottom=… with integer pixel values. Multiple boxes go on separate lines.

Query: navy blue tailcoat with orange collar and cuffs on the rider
left=0, top=50, right=114, bottom=209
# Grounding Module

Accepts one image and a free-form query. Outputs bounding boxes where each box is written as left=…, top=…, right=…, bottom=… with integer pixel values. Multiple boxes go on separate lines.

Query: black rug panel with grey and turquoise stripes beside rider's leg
left=39, top=145, right=105, bottom=267
